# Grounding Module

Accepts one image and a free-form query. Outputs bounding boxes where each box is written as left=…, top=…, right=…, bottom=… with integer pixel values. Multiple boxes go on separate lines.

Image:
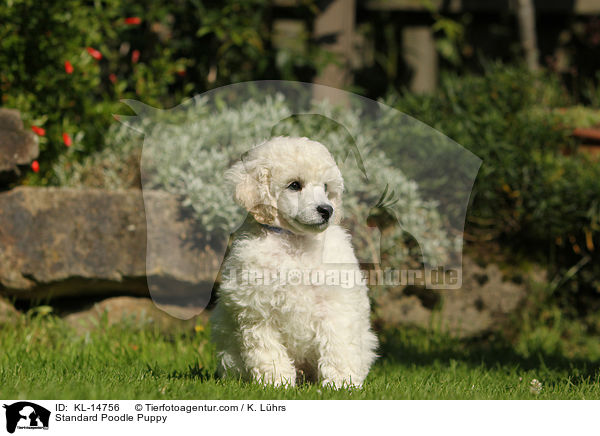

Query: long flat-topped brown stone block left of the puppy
left=0, top=187, right=220, bottom=317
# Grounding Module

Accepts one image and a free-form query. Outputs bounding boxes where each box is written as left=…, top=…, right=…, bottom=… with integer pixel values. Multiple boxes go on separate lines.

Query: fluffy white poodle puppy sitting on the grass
left=212, top=137, right=377, bottom=388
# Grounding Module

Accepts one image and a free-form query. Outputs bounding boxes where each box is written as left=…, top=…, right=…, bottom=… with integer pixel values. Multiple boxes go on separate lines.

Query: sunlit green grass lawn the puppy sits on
left=0, top=316, right=600, bottom=399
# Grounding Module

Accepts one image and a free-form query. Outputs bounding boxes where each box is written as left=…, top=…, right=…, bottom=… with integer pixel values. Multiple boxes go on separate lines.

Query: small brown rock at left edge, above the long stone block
left=0, top=108, right=39, bottom=186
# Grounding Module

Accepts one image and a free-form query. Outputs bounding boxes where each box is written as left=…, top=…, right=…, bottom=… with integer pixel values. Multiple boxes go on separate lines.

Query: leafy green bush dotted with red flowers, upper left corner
left=0, top=0, right=175, bottom=181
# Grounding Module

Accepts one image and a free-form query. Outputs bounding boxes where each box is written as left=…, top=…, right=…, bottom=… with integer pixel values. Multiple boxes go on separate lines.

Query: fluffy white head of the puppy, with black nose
left=227, top=137, right=344, bottom=234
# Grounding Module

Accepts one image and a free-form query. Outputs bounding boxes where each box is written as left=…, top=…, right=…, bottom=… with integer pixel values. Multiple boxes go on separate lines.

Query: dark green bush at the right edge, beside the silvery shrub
left=388, top=64, right=600, bottom=309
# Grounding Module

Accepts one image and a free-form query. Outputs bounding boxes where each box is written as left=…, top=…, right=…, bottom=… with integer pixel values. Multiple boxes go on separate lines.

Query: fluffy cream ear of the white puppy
left=225, top=160, right=277, bottom=224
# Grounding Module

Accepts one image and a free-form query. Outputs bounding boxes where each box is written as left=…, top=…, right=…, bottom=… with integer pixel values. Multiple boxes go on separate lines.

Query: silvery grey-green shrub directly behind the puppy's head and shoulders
left=57, top=95, right=456, bottom=267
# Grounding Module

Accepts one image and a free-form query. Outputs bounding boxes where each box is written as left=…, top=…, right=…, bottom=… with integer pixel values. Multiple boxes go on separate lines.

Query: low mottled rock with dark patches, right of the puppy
left=376, top=256, right=528, bottom=338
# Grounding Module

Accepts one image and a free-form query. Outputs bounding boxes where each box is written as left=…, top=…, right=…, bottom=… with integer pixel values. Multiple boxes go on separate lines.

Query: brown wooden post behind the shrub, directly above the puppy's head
left=313, top=0, right=356, bottom=104
